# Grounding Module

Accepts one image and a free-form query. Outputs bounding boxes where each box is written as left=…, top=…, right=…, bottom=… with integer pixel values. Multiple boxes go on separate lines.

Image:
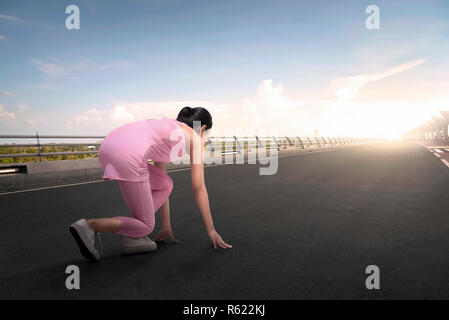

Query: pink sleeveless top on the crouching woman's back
left=98, top=117, right=186, bottom=181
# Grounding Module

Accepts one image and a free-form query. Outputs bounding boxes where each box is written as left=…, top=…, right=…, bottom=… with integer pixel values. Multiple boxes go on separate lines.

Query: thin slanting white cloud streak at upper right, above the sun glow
left=331, top=59, right=425, bottom=100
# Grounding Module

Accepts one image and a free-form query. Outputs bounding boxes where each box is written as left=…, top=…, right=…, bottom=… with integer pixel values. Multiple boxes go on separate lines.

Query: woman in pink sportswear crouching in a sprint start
left=70, top=107, right=232, bottom=261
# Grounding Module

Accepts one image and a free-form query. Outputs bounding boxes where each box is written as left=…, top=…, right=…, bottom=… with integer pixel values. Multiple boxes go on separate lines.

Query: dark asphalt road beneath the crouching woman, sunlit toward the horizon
left=0, top=143, right=449, bottom=299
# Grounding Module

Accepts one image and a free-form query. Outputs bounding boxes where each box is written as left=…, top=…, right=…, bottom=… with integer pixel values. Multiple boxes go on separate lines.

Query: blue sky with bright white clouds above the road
left=0, top=0, right=449, bottom=137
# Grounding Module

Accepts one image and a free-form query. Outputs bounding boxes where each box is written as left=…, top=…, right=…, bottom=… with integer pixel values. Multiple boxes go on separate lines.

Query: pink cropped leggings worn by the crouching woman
left=117, top=164, right=173, bottom=238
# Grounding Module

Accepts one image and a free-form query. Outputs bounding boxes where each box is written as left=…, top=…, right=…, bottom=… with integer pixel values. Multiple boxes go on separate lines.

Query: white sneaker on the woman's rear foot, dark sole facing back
left=70, top=219, right=103, bottom=261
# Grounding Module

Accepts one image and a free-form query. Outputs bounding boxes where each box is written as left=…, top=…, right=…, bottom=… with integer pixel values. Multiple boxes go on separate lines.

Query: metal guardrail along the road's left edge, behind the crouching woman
left=0, top=133, right=380, bottom=162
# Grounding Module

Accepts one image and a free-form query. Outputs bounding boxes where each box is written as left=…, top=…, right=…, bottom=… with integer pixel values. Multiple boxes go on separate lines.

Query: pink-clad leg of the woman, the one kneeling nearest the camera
left=117, top=180, right=156, bottom=238
